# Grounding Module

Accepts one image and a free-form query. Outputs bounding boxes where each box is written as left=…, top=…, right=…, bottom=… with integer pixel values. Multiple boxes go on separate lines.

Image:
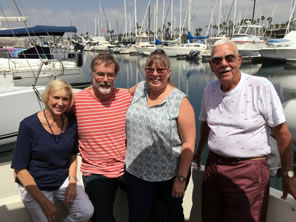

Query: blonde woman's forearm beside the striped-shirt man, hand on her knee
left=65, top=155, right=77, bottom=206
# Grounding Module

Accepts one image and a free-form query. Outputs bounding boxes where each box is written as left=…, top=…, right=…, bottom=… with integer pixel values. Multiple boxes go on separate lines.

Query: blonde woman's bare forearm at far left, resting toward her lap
left=15, top=169, right=58, bottom=222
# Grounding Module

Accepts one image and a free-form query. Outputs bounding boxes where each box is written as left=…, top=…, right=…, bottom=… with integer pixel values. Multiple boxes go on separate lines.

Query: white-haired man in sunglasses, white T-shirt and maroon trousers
left=195, top=39, right=296, bottom=222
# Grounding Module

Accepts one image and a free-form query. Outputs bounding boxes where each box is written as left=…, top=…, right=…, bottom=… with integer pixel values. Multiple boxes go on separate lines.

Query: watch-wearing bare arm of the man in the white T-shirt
left=272, top=123, right=296, bottom=199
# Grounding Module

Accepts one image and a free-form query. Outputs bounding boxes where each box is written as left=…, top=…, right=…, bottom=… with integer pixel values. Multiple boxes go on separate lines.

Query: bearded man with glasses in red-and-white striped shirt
left=75, top=54, right=131, bottom=222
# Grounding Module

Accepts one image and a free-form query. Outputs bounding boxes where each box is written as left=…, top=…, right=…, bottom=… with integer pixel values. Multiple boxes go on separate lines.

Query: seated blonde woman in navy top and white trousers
left=11, top=80, right=93, bottom=222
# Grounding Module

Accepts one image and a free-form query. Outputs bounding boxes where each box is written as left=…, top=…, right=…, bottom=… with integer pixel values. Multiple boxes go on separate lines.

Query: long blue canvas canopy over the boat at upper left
left=0, top=25, right=77, bottom=37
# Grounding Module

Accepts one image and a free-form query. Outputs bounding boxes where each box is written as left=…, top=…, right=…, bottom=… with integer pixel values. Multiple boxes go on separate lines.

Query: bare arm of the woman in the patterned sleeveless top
left=172, top=98, right=196, bottom=197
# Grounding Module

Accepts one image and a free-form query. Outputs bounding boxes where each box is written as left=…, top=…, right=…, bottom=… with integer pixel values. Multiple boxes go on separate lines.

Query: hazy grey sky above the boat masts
left=0, top=0, right=292, bottom=34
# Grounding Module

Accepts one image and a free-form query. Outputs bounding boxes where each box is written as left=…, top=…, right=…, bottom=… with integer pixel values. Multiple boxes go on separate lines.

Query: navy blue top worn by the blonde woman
left=11, top=113, right=78, bottom=191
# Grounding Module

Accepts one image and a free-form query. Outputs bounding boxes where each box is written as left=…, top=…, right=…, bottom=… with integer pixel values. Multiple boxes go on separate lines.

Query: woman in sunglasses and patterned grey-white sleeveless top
left=125, top=50, right=196, bottom=222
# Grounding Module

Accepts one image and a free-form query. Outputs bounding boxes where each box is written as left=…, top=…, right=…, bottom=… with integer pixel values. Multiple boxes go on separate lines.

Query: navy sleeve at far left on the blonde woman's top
left=11, top=120, right=32, bottom=169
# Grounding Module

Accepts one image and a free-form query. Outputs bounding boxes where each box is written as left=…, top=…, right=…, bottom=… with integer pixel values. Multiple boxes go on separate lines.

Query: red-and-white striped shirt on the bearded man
left=74, top=88, right=131, bottom=178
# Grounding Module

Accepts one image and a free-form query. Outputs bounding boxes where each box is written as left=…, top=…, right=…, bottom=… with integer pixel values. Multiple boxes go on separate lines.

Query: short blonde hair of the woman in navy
left=42, top=79, right=74, bottom=112
